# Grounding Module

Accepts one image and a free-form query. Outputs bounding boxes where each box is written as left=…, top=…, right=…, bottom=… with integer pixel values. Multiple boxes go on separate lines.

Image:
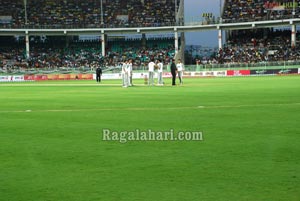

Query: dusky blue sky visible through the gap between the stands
left=184, top=0, right=220, bottom=47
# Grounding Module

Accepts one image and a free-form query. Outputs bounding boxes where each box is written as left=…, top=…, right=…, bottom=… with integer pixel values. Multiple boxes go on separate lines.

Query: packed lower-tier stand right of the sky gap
left=195, top=29, right=300, bottom=64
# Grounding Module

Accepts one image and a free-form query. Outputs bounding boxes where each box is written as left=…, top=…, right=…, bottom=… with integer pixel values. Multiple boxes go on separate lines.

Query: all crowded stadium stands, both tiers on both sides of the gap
left=0, top=0, right=300, bottom=69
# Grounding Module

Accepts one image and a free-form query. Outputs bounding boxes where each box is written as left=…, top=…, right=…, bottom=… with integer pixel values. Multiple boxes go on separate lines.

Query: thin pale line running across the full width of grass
left=0, top=103, right=300, bottom=113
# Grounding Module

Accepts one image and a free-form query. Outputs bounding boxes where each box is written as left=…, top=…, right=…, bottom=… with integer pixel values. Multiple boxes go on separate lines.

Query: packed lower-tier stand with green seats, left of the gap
left=0, top=37, right=175, bottom=69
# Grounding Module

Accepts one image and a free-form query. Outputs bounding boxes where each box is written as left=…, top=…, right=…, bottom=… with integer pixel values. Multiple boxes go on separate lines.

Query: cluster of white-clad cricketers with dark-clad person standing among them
left=121, top=59, right=184, bottom=87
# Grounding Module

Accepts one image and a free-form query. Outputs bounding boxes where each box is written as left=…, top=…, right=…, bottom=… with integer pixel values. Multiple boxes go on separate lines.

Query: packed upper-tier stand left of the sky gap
left=0, top=0, right=180, bottom=28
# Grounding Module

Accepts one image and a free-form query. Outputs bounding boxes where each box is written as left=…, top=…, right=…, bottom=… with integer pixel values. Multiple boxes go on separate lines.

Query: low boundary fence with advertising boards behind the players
left=0, top=61, right=300, bottom=75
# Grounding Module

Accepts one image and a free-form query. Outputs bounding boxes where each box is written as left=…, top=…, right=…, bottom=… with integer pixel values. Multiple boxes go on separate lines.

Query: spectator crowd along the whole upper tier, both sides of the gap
left=0, top=0, right=300, bottom=28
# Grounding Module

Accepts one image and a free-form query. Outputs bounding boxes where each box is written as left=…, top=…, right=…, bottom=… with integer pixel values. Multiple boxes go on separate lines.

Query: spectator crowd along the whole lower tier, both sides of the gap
left=0, top=29, right=300, bottom=69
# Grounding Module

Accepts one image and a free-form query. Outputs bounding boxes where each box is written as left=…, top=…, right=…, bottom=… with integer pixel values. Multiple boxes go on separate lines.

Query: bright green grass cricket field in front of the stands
left=0, top=76, right=300, bottom=201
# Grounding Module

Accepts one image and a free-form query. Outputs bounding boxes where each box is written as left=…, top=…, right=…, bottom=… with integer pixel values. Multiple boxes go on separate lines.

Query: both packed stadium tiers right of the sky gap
left=217, top=0, right=300, bottom=63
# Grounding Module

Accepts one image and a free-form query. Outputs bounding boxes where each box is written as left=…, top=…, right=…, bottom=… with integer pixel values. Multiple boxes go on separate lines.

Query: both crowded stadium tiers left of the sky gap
left=0, top=0, right=180, bottom=69
